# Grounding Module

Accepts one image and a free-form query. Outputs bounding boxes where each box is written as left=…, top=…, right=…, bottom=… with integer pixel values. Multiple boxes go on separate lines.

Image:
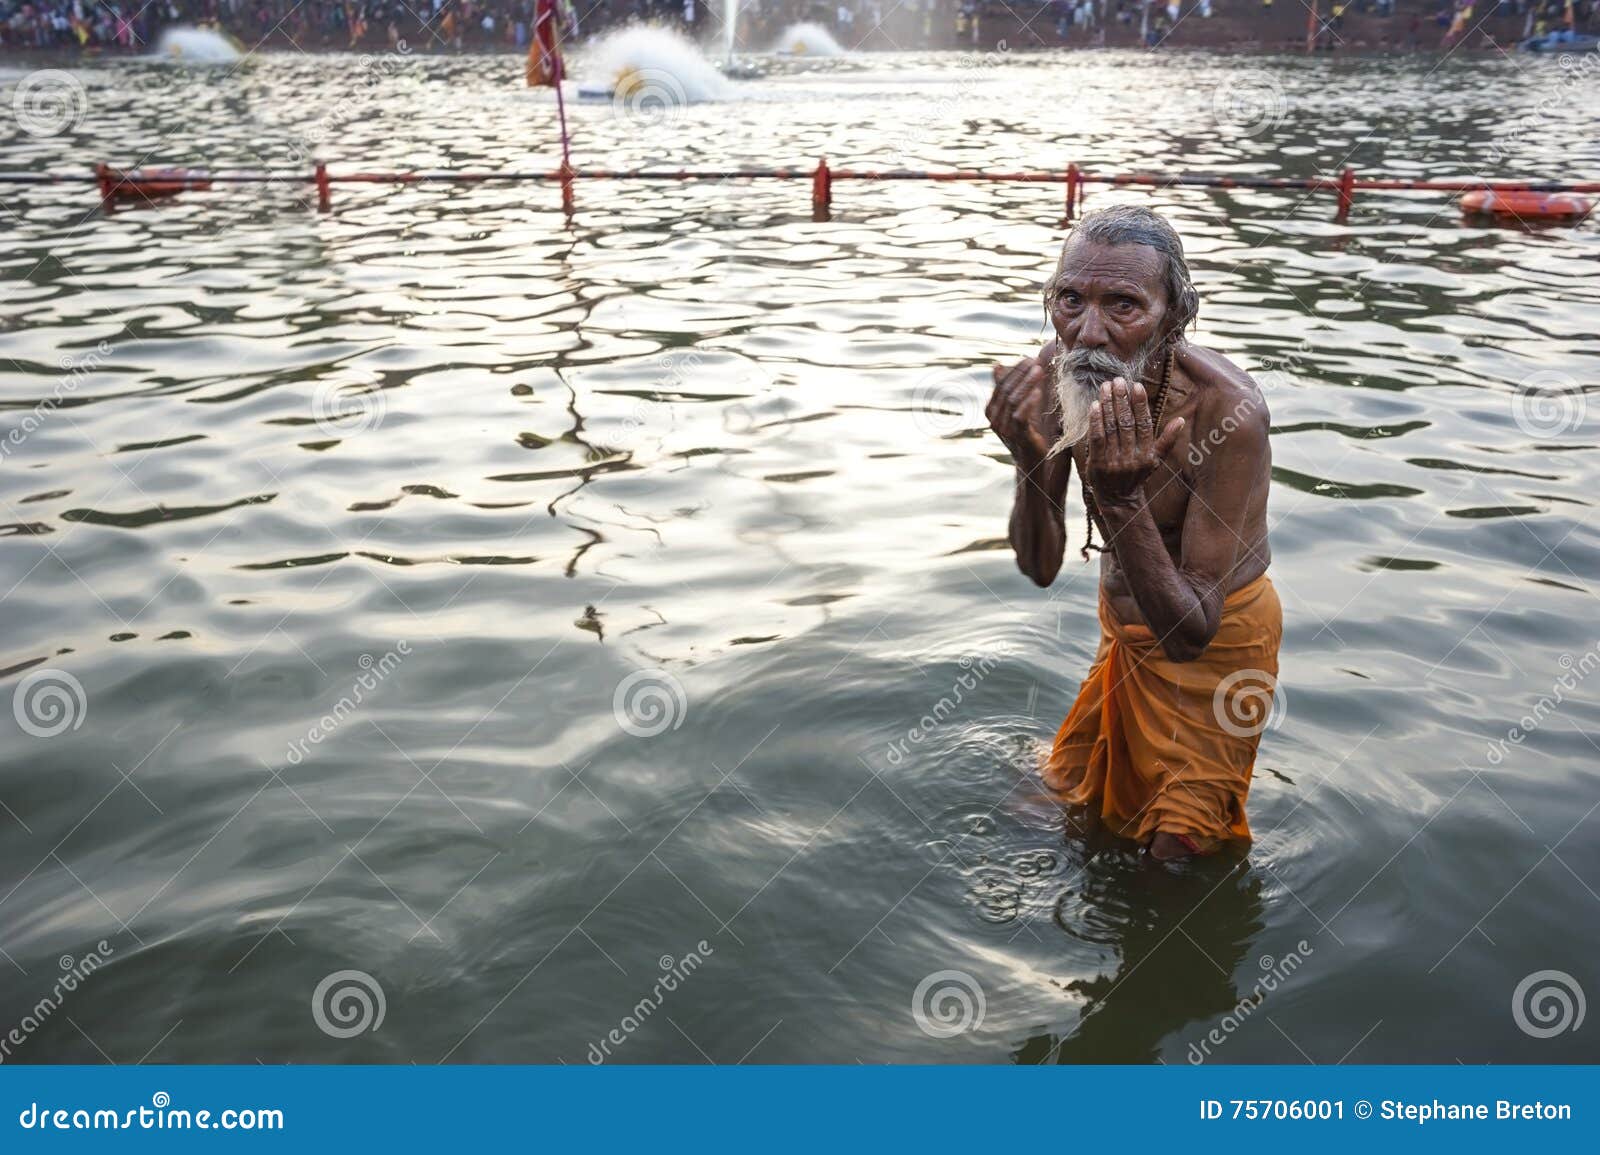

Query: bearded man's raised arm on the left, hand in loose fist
left=987, top=344, right=1072, bottom=585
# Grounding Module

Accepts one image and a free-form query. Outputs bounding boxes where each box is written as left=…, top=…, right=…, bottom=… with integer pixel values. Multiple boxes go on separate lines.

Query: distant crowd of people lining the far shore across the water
left=0, top=0, right=1600, bottom=53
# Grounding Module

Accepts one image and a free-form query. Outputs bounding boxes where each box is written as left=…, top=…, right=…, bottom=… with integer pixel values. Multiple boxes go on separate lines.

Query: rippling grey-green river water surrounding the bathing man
left=0, top=53, right=1600, bottom=1062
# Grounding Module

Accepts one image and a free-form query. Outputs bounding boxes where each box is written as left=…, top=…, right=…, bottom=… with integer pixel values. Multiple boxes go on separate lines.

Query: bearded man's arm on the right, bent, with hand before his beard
left=1090, top=382, right=1267, bottom=662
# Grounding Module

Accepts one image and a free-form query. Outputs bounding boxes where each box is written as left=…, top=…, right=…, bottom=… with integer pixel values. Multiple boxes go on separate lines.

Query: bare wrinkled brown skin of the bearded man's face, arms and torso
left=987, top=238, right=1272, bottom=859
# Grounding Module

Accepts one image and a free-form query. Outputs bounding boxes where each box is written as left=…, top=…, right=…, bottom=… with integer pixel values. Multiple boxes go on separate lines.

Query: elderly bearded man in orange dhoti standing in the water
left=987, top=206, right=1283, bottom=859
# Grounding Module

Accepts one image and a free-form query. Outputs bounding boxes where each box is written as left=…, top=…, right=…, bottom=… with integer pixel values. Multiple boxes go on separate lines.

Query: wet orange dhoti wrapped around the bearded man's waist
left=1043, top=574, right=1283, bottom=849
